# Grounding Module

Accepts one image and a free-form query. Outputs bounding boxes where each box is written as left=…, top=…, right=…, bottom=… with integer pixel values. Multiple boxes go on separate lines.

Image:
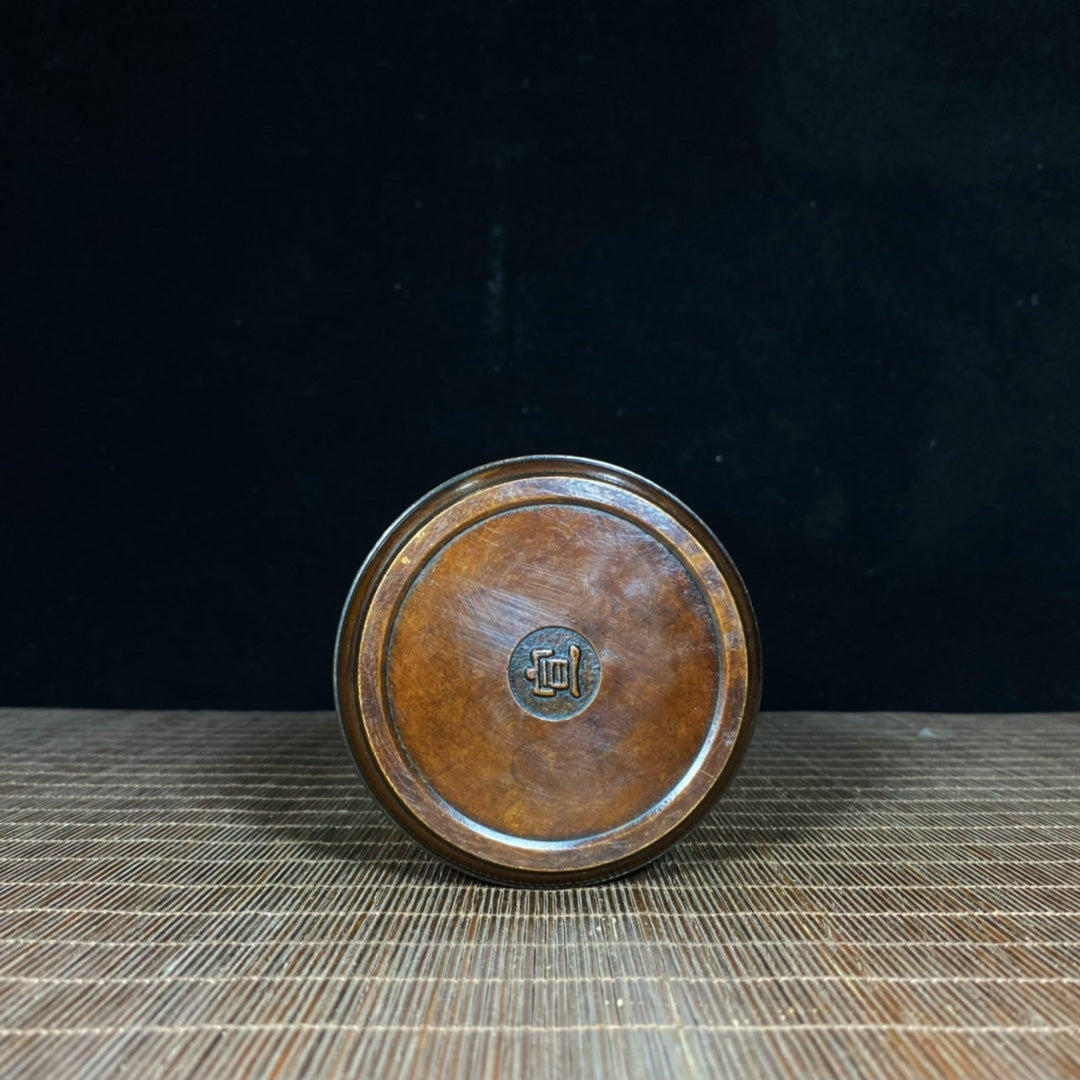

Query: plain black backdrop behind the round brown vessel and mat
left=0, top=0, right=1080, bottom=710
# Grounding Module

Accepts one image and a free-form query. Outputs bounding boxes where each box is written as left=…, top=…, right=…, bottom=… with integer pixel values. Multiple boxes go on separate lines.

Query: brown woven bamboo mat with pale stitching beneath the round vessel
left=0, top=710, right=1080, bottom=1080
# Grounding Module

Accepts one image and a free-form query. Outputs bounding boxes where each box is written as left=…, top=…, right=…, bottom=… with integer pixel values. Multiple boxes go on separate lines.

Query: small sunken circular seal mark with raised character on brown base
left=508, top=626, right=600, bottom=720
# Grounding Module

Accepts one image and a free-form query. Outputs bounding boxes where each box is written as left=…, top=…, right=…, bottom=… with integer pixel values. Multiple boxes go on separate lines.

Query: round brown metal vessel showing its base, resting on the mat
left=336, top=457, right=760, bottom=885
